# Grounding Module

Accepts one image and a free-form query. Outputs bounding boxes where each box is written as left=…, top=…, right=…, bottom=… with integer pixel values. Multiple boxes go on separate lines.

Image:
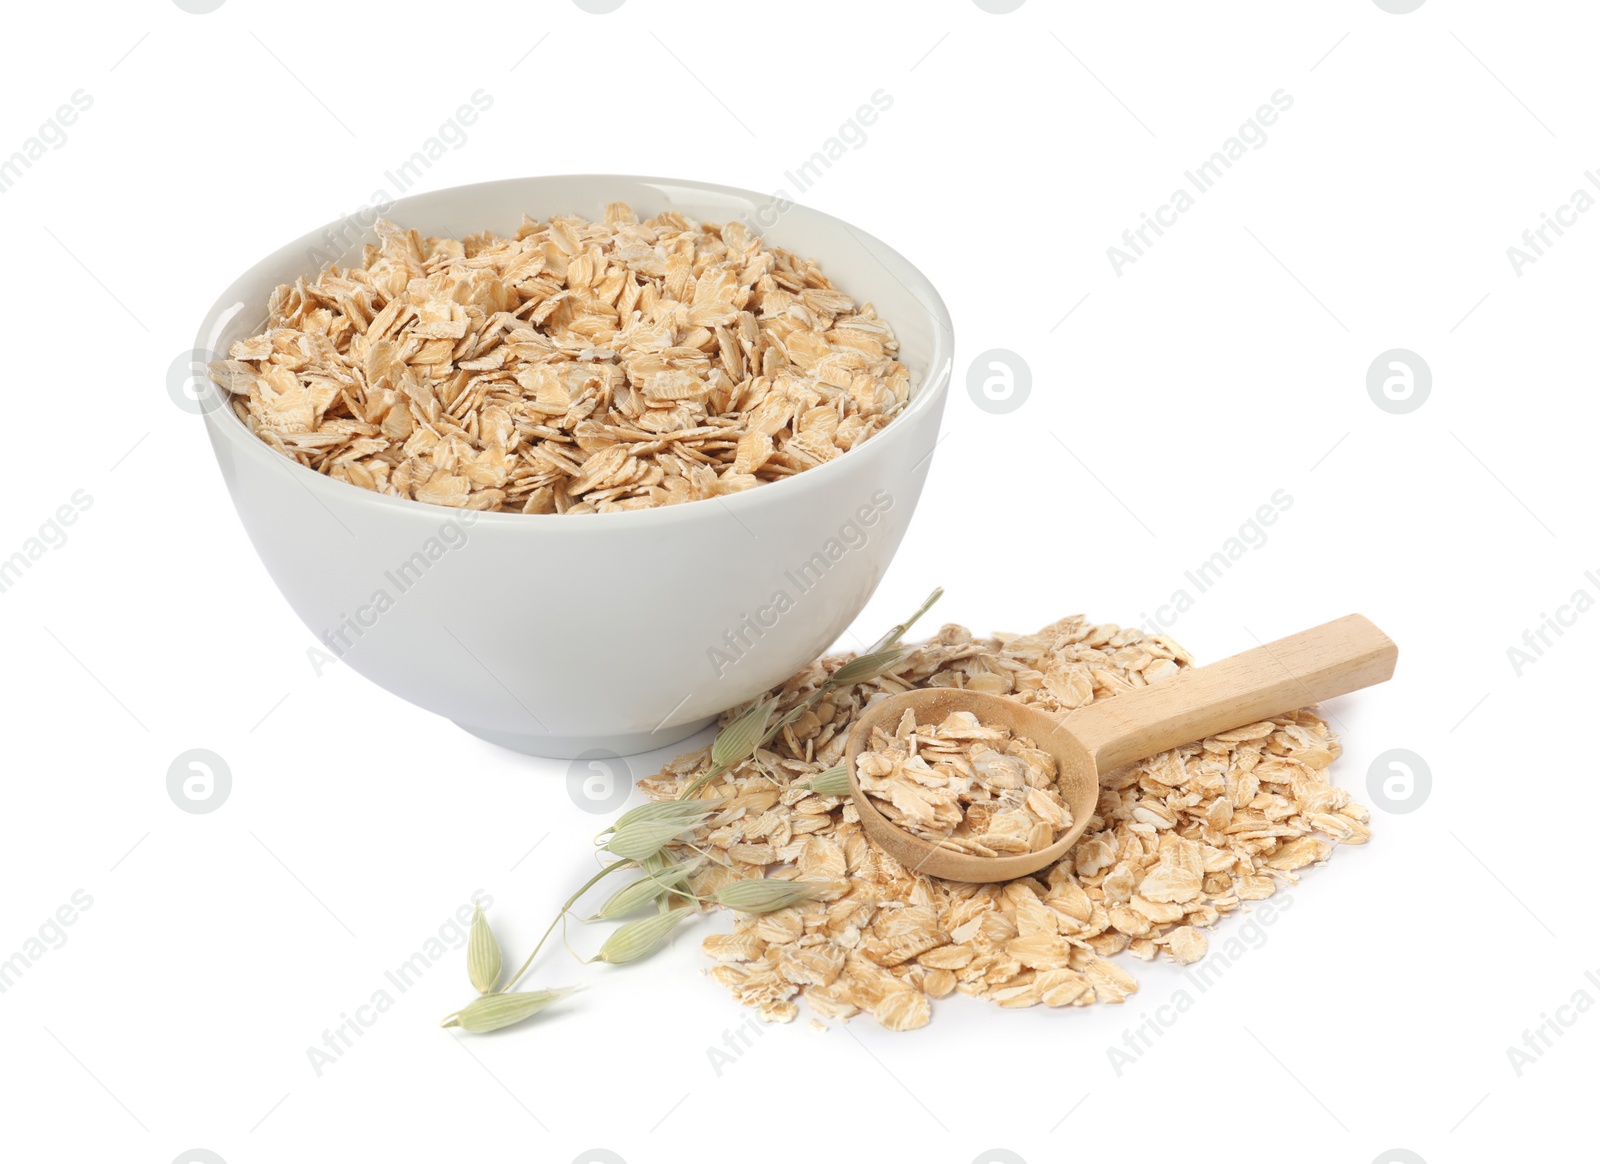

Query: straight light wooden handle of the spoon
left=1064, top=614, right=1398, bottom=772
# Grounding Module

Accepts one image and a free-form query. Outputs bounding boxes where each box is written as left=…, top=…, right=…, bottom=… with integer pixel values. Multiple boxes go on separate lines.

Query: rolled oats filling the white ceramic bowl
left=210, top=203, right=910, bottom=513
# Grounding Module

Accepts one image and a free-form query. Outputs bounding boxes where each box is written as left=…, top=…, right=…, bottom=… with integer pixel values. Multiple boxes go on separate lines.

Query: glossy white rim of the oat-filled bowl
left=195, top=174, right=955, bottom=532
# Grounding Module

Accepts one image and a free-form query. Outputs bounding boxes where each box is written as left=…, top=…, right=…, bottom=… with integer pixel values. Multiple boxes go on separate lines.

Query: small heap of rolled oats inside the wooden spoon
left=856, top=708, right=1072, bottom=857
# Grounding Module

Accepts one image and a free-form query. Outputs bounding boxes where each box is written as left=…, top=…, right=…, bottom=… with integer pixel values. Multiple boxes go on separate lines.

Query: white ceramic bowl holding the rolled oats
left=195, top=174, right=954, bottom=756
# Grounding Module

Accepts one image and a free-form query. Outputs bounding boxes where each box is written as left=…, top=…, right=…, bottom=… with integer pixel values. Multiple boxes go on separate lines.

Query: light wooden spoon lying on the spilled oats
left=845, top=614, right=1398, bottom=881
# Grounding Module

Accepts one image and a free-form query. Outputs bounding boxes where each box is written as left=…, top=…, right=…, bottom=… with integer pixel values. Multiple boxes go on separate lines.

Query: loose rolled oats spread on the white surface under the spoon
left=642, top=617, right=1370, bottom=1030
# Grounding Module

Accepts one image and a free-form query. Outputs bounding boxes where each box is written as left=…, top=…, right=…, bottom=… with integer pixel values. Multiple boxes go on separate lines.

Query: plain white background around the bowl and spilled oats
left=0, top=0, right=1600, bottom=1164
